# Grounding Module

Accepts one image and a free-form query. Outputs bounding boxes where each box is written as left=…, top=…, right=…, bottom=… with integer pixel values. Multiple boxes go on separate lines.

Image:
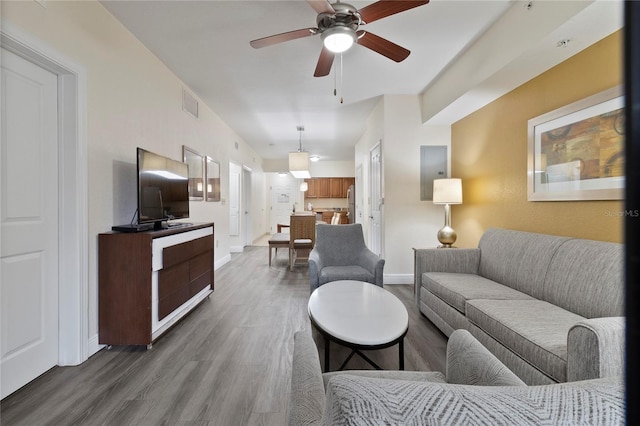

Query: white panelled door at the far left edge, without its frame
left=0, top=49, right=58, bottom=398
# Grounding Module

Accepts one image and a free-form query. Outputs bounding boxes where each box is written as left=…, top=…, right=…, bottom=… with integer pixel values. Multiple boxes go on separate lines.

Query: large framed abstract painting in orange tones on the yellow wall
left=527, top=86, right=625, bottom=201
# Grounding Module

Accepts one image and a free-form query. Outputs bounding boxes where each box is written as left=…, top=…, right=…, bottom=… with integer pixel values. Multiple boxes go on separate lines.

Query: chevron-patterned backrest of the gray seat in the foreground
left=324, top=374, right=625, bottom=425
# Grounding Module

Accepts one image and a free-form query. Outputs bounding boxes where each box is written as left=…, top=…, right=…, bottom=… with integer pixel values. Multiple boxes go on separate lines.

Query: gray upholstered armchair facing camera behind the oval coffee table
left=309, top=223, right=384, bottom=292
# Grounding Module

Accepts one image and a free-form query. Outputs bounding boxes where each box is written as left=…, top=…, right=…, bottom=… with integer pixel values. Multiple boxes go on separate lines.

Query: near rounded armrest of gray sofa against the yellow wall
left=567, top=317, right=625, bottom=382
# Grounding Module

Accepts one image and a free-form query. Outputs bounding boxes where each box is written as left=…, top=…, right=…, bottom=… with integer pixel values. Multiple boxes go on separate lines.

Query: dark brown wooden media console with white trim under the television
left=98, top=223, right=214, bottom=348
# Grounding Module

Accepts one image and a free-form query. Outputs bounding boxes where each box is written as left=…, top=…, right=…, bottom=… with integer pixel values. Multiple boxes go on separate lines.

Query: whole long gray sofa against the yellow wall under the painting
left=415, top=228, right=624, bottom=385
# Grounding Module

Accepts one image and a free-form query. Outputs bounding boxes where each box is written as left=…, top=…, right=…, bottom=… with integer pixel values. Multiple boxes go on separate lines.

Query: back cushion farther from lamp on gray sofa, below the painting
left=542, top=239, right=624, bottom=318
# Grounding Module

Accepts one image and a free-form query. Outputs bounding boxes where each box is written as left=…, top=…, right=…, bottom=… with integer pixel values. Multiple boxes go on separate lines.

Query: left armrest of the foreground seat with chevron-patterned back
left=289, top=331, right=325, bottom=426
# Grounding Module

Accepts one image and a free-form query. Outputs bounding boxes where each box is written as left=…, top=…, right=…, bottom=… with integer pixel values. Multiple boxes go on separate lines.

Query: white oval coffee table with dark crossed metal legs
left=308, top=281, right=409, bottom=371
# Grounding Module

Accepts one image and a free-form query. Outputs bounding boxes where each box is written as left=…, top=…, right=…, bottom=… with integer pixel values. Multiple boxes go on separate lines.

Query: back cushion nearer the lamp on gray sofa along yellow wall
left=478, top=228, right=569, bottom=299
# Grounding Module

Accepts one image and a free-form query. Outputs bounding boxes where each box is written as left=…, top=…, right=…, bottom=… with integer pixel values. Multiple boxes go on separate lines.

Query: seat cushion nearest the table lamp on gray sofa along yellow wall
left=422, top=272, right=533, bottom=313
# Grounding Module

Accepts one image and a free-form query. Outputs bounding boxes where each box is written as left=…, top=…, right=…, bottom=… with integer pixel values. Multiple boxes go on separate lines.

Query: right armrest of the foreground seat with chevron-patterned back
left=446, top=329, right=526, bottom=386
